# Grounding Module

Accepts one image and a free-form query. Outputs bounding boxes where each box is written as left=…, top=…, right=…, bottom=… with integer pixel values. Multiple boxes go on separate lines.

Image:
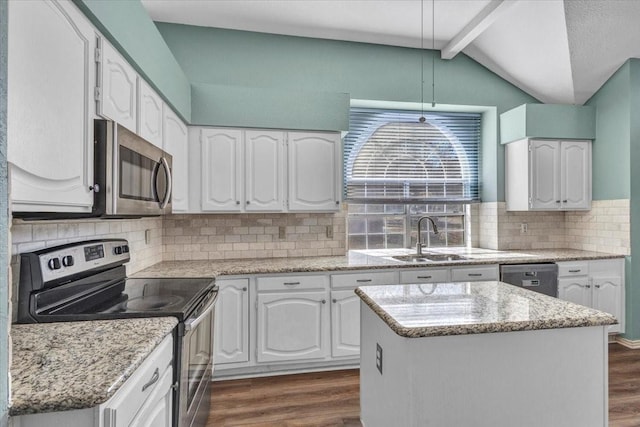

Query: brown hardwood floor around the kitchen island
left=208, top=344, right=640, bottom=427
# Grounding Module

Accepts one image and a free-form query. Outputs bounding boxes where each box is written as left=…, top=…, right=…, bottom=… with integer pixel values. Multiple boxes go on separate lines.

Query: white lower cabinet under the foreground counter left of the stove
left=10, top=334, right=173, bottom=427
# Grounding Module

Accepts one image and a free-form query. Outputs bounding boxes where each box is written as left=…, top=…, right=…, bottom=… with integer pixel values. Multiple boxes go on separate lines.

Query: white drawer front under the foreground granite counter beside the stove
left=103, top=334, right=173, bottom=427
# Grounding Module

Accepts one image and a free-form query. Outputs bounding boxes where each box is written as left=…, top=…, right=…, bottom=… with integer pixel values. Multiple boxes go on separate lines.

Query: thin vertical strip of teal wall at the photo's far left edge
left=0, top=0, right=10, bottom=426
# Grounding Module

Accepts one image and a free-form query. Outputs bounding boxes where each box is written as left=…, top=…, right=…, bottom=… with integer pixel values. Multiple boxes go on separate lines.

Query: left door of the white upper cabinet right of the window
left=529, top=140, right=561, bottom=210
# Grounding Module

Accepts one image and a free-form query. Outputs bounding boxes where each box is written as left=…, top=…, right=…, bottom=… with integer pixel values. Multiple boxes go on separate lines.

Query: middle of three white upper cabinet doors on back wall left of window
left=244, top=131, right=284, bottom=212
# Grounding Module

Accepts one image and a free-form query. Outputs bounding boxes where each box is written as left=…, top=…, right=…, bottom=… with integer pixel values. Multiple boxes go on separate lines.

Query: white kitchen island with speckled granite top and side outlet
left=356, top=282, right=616, bottom=427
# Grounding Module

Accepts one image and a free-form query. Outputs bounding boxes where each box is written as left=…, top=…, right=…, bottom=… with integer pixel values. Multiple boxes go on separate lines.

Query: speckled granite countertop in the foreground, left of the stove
left=9, top=317, right=178, bottom=416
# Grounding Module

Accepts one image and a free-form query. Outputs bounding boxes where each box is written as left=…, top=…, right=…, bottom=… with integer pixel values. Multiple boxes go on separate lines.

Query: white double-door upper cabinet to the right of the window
left=505, top=139, right=591, bottom=211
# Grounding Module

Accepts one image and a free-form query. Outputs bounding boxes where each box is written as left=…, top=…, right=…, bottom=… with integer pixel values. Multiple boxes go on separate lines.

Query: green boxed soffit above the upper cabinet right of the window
left=500, top=104, right=596, bottom=144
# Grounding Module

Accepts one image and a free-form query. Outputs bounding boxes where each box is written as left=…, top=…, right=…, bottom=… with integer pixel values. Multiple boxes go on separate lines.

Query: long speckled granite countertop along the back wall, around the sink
left=133, top=248, right=623, bottom=277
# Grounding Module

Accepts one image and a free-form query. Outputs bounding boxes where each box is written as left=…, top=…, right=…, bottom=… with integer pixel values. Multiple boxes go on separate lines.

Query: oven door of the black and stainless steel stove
left=179, top=294, right=217, bottom=427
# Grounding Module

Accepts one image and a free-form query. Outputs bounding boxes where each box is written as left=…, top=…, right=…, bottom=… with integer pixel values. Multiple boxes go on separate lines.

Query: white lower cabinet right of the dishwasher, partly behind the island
left=557, top=258, right=625, bottom=333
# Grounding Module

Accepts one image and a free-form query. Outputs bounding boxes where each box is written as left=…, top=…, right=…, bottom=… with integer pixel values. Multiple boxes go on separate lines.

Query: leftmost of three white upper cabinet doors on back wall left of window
left=201, top=129, right=243, bottom=212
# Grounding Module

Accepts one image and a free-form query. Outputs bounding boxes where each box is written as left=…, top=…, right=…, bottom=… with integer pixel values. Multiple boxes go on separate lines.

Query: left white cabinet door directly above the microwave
left=98, top=38, right=138, bottom=132
